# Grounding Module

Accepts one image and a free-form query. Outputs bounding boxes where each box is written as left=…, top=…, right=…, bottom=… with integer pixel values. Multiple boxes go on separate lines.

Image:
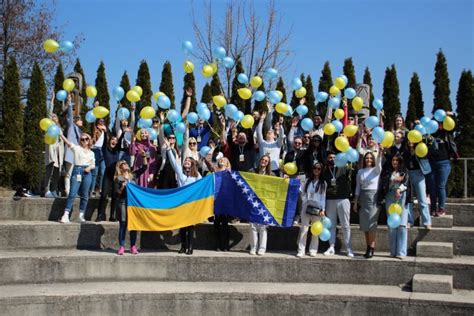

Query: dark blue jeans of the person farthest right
left=430, top=160, right=451, bottom=211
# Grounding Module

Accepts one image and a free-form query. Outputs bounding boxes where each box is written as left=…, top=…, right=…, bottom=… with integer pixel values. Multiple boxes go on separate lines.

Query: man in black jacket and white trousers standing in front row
left=322, top=152, right=354, bottom=257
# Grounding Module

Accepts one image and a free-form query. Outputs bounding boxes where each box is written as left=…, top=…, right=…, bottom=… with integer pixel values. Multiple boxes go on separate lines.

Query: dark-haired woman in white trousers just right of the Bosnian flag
left=296, top=161, right=326, bottom=258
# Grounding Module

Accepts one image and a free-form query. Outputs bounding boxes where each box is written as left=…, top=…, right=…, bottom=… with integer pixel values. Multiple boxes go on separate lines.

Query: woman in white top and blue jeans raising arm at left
left=60, top=133, right=95, bottom=223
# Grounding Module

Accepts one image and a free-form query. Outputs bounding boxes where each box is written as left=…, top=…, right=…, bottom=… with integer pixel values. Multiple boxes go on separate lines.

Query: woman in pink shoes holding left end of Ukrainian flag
left=114, top=160, right=138, bottom=255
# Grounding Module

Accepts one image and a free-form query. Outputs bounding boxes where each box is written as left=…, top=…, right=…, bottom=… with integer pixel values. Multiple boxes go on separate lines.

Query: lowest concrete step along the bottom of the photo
left=0, top=282, right=474, bottom=316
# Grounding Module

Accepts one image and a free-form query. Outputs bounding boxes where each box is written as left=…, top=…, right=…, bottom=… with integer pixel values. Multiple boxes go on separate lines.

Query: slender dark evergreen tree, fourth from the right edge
left=383, top=65, right=400, bottom=130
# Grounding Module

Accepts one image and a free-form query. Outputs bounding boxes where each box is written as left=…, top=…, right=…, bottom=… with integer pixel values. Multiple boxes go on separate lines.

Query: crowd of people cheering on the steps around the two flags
left=44, top=89, right=457, bottom=258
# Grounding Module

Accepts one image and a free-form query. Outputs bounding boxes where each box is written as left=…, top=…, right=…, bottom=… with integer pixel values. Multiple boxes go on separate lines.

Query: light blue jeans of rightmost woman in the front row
left=385, top=191, right=408, bottom=257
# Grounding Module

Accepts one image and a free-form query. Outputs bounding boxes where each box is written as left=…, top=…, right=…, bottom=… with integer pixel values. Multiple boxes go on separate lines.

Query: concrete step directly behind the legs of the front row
left=0, top=221, right=474, bottom=256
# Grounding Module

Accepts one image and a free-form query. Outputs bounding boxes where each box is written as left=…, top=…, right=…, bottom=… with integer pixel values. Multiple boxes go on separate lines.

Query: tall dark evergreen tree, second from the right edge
left=432, top=49, right=452, bottom=113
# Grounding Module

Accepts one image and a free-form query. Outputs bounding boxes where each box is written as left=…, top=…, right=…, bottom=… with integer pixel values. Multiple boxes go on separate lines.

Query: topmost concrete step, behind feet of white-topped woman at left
left=0, top=198, right=474, bottom=227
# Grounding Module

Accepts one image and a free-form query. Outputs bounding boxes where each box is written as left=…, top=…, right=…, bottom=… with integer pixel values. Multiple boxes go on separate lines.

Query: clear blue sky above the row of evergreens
left=54, top=0, right=474, bottom=113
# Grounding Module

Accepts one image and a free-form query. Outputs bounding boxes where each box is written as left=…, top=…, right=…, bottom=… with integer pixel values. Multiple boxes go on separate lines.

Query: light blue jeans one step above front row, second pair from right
left=408, top=170, right=431, bottom=226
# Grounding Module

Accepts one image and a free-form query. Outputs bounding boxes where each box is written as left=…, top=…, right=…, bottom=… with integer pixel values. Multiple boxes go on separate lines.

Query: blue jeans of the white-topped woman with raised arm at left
left=65, top=166, right=92, bottom=213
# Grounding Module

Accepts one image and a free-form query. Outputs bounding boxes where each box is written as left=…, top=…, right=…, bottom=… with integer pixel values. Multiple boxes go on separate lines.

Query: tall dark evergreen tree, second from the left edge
left=23, top=63, right=47, bottom=193
